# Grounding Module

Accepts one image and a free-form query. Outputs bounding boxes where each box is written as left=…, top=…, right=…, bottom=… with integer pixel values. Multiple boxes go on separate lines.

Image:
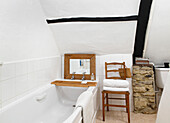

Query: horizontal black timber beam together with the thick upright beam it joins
left=46, top=0, right=152, bottom=63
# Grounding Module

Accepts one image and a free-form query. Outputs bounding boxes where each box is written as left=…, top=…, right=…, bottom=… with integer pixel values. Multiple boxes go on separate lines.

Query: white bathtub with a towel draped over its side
left=0, top=84, right=97, bottom=123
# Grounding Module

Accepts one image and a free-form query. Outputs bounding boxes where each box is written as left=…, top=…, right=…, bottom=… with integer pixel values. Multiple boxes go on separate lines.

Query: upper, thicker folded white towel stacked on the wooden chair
left=103, top=79, right=129, bottom=88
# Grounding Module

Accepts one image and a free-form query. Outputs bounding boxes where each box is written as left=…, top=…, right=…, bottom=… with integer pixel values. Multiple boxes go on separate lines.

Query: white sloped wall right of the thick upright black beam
left=145, top=0, right=170, bottom=64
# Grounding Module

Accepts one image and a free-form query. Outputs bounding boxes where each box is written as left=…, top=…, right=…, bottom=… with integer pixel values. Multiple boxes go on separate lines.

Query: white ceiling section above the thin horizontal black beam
left=40, top=0, right=140, bottom=18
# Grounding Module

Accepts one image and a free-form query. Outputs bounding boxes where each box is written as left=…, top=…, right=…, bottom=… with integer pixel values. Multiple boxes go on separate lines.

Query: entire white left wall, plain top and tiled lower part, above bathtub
left=0, top=0, right=61, bottom=110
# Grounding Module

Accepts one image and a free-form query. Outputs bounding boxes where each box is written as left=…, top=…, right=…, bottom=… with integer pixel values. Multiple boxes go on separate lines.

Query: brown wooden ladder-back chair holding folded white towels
left=102, top=62, right=130, bottom=123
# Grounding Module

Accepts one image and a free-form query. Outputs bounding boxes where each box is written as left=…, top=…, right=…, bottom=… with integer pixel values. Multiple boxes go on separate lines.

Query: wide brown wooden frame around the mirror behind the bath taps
left=64, top=54, right=96, bottom=80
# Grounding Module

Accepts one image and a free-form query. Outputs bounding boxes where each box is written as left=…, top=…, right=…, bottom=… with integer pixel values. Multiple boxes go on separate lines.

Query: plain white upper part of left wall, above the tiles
left=0, top=0, right=59, bottom=62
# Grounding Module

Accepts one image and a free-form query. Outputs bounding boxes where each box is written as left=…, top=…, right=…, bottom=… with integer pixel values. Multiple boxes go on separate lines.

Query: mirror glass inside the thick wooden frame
left=70, top=59, right=90, bottom=74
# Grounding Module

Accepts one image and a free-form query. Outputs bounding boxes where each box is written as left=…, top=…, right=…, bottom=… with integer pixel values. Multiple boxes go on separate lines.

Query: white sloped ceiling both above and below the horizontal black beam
left=40, top=0, right=140, bottom=55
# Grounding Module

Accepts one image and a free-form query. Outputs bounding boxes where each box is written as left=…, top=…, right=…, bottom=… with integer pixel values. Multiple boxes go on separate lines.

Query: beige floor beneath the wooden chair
left=96, top=111, right=156, bottom=123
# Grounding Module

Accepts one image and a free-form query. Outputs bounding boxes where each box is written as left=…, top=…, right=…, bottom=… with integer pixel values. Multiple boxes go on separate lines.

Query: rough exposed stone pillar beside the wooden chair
left=132, top=65, right=156, bottom=114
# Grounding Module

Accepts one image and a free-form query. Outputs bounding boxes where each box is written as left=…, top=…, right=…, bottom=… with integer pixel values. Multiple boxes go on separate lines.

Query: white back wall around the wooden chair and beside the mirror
left=62, top=54, right=133, bottom=111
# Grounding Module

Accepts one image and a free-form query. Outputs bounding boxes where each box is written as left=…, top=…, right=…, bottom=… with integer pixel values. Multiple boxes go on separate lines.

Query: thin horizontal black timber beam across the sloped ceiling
left=46, top=15, right=138, bottom=24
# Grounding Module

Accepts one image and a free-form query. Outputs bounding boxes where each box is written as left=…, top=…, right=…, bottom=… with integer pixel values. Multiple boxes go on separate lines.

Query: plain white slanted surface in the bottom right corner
left=156, top=72, right=170, bottom=123
